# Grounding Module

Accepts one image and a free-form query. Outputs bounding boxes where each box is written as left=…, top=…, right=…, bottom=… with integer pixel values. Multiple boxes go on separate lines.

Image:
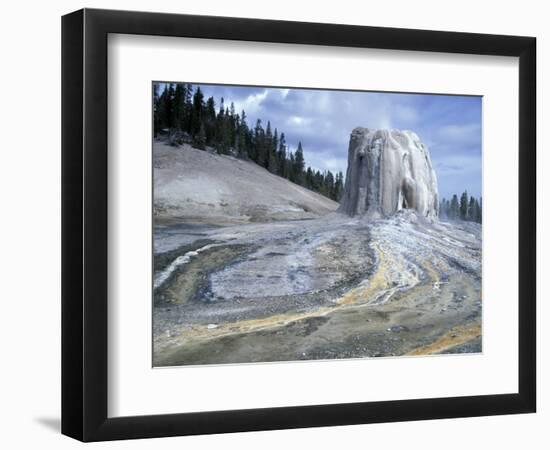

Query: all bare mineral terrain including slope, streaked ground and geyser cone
left=153, top=128, right=481, bottom=366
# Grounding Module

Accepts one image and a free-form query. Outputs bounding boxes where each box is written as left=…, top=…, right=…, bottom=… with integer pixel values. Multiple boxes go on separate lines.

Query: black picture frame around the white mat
left=62, top=9, right=536, bottom=441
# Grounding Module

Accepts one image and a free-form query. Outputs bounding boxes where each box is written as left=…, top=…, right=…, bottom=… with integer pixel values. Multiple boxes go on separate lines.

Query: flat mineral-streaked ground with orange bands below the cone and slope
left=153, top=210, right=481, bottom=366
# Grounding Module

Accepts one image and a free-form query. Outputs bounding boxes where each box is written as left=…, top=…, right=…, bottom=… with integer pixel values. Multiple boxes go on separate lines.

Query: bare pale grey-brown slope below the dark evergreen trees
left=153, top=142, right=338, bottom=224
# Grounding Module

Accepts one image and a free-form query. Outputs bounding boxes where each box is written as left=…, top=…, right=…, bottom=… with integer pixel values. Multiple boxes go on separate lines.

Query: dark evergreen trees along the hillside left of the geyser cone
left=153, top=83, right=344, bottom=201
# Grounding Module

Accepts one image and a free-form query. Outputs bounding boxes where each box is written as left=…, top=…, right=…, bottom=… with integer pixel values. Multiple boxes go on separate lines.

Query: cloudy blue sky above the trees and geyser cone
left=184, top=85, right=482, bottom=198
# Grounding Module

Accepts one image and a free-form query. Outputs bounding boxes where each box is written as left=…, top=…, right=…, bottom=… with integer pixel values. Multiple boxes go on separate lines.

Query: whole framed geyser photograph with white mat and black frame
left=62, top=9, right=536, bottom=441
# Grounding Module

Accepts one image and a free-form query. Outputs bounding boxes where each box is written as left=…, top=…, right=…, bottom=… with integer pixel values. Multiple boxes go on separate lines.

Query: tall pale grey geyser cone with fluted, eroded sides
left=338, top=127, right=439, bottom=219
